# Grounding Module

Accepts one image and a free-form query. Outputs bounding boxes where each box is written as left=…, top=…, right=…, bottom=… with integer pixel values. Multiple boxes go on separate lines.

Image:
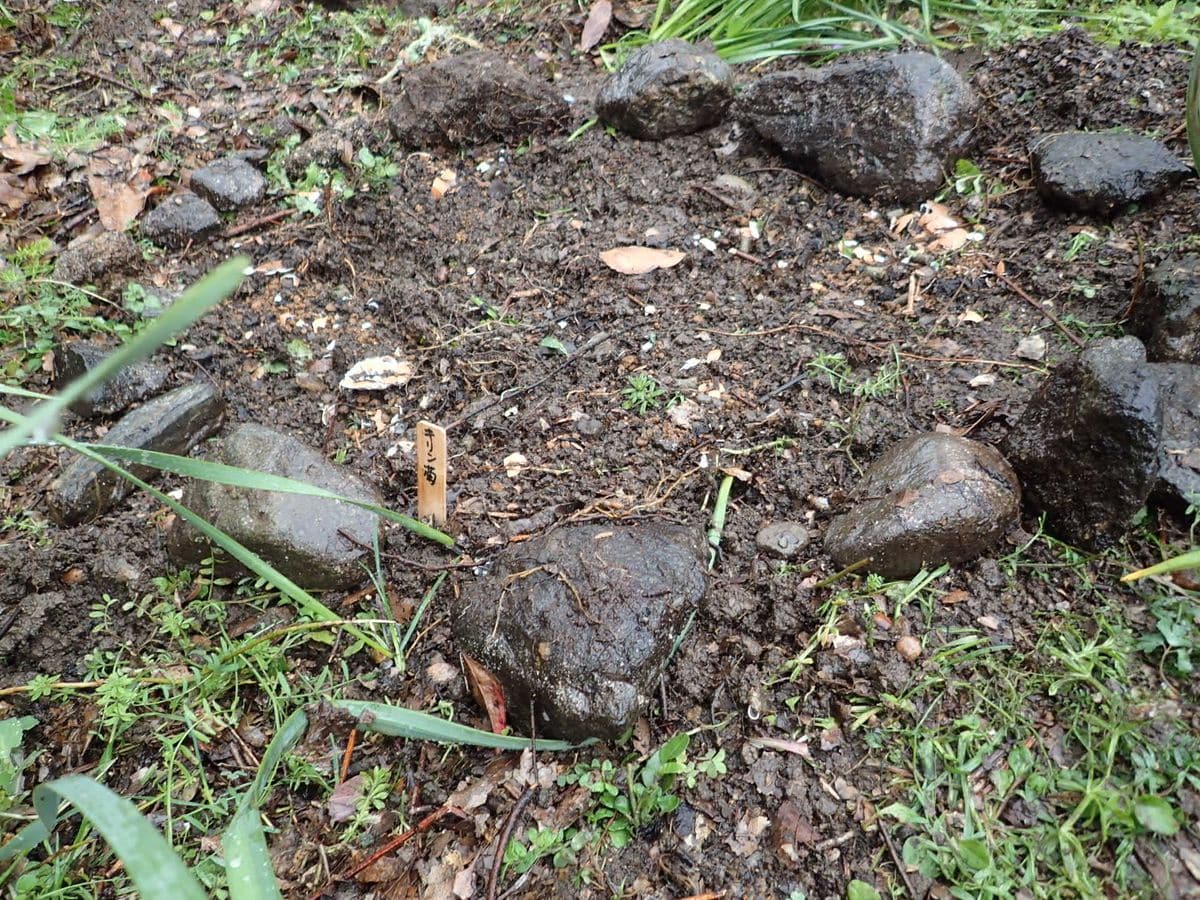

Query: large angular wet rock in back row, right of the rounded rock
left=736, top=52, right=976, bottom=202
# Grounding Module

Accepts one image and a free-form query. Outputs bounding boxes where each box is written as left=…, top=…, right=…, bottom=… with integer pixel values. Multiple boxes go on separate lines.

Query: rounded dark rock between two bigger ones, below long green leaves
left=596, top=40, right=733, bottom=140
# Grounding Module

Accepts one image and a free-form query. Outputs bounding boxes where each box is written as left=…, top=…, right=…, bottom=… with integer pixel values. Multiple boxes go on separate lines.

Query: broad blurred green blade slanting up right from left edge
left=0, top=257, right=250, bottom=460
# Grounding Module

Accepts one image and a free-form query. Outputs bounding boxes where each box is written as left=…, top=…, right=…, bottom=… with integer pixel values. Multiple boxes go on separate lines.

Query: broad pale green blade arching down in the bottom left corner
left=27, top=775, right=205, bottom=900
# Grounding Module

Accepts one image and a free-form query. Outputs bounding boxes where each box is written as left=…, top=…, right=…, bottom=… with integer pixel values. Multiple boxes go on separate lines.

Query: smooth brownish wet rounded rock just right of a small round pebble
left=824, top=433, right=1021, bottom=578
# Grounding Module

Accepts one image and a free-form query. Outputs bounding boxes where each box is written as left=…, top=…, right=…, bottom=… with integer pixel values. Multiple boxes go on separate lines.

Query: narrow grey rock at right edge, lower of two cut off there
left=1148, top=362, right=1200, bottom=514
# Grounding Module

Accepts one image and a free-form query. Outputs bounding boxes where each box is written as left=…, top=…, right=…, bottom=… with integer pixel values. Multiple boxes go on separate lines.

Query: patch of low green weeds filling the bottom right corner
left=873, top=616, right=1200, bottom=898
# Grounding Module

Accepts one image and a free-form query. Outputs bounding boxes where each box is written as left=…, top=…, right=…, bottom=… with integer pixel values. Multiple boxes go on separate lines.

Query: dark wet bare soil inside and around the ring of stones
left=0, top=2, right=1200, bottom=898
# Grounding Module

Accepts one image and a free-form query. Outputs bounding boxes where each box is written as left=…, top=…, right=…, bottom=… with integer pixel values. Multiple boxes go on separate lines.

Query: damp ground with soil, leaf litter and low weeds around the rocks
left=0, top=7, right=1200, bottom=898
